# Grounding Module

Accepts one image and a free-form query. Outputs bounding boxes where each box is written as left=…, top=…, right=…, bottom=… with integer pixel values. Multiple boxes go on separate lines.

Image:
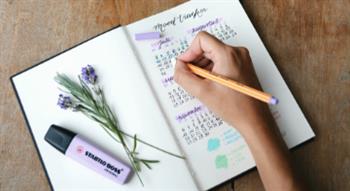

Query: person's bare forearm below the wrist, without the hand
left=240, top=106, right=302, bottom=191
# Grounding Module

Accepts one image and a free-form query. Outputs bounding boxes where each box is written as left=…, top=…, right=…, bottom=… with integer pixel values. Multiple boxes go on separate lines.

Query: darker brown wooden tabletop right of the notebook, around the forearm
left=235, top=0, right=350, bottom=191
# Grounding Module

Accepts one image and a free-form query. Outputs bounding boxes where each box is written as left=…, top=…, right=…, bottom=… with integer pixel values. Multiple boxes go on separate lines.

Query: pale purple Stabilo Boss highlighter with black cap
left=45, top=125, right=131, bottom=184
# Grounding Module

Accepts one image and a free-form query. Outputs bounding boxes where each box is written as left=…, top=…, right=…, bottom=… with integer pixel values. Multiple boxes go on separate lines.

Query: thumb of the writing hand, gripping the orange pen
left=174, top=59, right=209, bottom=98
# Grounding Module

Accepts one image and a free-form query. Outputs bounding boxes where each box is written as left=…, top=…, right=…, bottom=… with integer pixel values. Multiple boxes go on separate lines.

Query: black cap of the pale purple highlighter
left=45, top=125, right=77, bottom=154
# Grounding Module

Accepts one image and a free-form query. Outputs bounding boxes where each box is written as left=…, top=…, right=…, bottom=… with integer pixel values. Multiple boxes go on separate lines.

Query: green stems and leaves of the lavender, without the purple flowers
left=55, top=74, right=185, bottom=186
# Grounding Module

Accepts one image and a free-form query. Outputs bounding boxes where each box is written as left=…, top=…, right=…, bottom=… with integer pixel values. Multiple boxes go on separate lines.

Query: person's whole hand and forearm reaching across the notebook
left=174, top=32, right=301, bottom=190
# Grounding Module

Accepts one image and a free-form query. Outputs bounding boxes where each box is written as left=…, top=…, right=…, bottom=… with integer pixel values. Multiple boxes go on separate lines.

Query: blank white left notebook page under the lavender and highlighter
left=13, top=28, right=196, bottom=191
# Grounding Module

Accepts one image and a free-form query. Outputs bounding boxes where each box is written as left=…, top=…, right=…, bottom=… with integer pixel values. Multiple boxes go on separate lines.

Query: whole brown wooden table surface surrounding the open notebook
left=0, top=0, right=350, bottom=191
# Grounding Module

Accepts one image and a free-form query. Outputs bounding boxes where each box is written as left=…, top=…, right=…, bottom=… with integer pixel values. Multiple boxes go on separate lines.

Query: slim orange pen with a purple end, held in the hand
left=171, top=58, right=278, bottom=105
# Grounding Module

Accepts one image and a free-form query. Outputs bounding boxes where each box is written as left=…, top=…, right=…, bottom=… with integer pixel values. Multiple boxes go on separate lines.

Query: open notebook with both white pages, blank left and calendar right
left=12, top=0, right=314, bottom=190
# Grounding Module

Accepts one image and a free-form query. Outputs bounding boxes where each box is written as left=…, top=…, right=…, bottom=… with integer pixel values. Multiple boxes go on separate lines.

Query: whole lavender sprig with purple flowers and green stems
left=55, top=65, right=184, bottom=185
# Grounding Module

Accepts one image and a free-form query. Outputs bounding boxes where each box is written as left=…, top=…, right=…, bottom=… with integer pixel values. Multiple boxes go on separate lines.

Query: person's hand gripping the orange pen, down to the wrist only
left=174, top=32, right=272, bottom=133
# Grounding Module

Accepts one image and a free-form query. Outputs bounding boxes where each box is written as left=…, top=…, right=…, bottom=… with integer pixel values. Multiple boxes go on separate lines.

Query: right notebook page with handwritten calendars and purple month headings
left=127, top=0, right=314, bottom=189
